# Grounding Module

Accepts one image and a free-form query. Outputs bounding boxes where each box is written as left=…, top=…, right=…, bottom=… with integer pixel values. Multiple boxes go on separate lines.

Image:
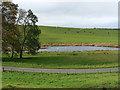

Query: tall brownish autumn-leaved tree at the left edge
left=1, top=2, right=20, bottom=57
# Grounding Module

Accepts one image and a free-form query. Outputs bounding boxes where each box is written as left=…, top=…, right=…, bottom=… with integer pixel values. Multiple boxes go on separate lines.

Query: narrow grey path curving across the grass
left=3, top=66, right=120, bottom=73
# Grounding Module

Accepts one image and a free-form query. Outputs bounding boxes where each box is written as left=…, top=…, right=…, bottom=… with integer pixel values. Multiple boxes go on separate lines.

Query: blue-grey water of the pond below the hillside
left=38, top=46, right=120, bottom=52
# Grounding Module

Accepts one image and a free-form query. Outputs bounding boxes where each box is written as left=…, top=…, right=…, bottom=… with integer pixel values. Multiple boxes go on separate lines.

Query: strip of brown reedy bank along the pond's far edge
left=41, top=43, right=120, bottom=47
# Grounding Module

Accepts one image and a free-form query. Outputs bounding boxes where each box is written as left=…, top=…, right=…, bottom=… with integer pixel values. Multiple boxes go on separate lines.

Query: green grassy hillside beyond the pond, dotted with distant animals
left=39, top=26, right=118, bottom=43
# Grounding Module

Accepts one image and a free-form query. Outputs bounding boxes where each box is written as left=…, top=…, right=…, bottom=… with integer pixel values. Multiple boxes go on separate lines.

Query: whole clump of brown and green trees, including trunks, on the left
left=2, top=2, right=41, bottom=58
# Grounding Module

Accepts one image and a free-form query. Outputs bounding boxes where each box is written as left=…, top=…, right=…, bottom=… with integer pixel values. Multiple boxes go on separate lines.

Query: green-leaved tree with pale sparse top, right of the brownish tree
left=17, top=9, right=41, bottom=58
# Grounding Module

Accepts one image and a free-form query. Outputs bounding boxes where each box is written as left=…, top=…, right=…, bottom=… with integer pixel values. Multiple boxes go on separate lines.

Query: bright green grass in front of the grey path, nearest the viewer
left=2, top=71, right=118, bottom=88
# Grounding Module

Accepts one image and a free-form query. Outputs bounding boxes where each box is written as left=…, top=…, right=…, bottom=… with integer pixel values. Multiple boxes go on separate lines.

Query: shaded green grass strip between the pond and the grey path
left=2, top=50, right=118, bottom=69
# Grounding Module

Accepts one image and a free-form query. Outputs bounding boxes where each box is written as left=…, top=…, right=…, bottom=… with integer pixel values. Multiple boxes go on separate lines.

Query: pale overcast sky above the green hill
left=13, top=0, right=118, bottom=28
